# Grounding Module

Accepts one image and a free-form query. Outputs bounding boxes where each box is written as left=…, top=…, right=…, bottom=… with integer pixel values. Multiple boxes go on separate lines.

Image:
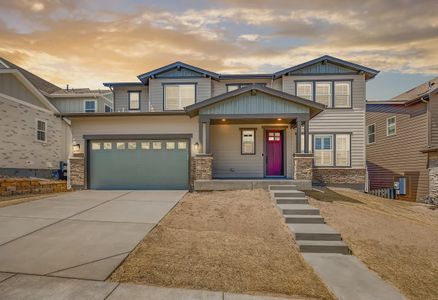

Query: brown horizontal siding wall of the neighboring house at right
left=366, top=103, right=429, bottom=201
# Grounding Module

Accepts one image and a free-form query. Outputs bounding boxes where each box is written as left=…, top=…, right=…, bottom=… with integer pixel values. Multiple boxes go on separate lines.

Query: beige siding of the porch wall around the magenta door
left=210, top=124, right=294, bottom=178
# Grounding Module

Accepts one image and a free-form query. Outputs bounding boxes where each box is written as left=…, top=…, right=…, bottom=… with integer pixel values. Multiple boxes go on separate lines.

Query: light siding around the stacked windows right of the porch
left=282, top=74, right=366, bottom=169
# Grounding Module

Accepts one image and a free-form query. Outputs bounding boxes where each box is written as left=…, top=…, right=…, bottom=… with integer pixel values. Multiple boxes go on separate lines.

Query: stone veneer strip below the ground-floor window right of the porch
left=313, top=168, right=366, bottom=184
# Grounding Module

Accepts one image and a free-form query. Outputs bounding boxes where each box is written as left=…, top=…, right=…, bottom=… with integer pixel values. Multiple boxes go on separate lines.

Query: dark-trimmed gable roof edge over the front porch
left=184, top=84, right=326, bottom=117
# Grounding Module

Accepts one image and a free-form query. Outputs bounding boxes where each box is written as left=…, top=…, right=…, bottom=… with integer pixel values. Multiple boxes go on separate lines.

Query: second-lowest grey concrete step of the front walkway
left=288, top=224, right=341, bottom=241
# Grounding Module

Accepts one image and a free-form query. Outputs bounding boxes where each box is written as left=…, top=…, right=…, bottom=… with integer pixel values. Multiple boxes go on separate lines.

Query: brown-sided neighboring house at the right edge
left=367, top=77, right=438, bottom=201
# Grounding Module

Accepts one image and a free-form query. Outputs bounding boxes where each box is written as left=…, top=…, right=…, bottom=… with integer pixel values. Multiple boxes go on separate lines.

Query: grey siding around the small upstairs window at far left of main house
left=113, top=85, right=149, bottom=112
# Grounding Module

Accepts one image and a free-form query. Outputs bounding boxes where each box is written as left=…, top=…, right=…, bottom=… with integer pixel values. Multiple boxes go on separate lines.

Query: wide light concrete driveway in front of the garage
left=0, top=191, right=186, bottom=280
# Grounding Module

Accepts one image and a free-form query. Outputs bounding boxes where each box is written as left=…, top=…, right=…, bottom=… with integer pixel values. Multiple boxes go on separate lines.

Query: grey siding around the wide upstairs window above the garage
left=149, top=77, right=211, bottom=111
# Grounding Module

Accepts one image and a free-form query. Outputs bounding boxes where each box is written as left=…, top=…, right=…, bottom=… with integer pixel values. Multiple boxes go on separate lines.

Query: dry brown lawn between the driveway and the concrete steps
left=110, top=190, right=334, bottom=299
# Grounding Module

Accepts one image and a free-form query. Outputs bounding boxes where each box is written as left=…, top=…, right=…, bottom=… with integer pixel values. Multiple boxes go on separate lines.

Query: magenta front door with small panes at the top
left=265, top=130, right=284, bottom=176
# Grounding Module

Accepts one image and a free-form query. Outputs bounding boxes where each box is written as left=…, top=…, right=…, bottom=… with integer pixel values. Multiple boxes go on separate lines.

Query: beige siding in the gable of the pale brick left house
left=0, top=74, right=47, bottom=109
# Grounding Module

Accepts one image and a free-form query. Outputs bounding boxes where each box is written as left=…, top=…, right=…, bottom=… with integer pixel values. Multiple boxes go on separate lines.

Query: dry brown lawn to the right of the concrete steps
left=311, top=188, right=438, bottom=300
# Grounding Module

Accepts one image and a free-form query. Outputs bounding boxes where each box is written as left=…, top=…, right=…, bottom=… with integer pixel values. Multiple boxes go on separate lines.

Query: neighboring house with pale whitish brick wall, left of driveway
left=0, top=58, right=112, bottom=178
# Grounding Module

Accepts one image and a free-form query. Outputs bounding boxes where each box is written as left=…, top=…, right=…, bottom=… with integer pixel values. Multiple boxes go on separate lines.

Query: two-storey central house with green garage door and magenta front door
left=61, top=56, right=378, bottom=189
